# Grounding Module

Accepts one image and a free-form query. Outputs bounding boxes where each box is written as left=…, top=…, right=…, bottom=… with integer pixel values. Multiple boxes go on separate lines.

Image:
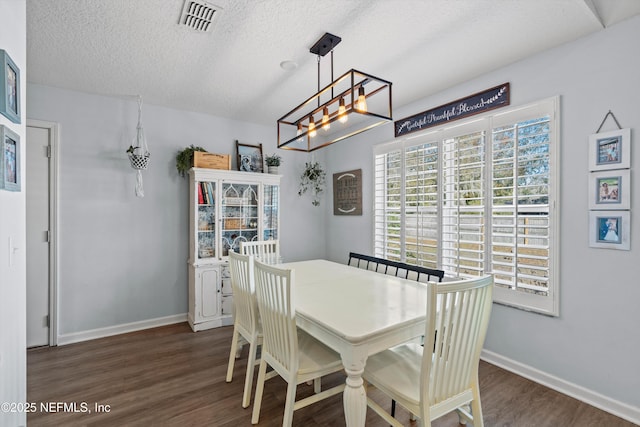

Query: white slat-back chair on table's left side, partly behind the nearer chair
left=226, top=250, right=263, bottom=408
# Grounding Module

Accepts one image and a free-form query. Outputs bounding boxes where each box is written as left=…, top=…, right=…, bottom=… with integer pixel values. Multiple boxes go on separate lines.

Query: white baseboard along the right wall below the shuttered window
left=480, top=350, right=640, bottom=425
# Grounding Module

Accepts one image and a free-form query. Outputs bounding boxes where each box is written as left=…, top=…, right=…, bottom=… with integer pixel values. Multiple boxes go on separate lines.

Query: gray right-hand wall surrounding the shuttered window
left=326, top=17, right=640, bottom=414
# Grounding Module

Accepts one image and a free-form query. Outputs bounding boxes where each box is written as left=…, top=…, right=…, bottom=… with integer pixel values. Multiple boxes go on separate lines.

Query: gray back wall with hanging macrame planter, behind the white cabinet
left=27, top=85, right=324, bottom=335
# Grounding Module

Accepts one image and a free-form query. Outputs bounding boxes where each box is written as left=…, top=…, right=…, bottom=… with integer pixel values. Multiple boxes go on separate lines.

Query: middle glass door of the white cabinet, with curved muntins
left=220, top=183, right=259, bottom=256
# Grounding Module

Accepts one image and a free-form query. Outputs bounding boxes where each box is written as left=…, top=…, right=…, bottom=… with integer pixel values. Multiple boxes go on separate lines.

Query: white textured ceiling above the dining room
left=27, top=0, right=640, bottom=126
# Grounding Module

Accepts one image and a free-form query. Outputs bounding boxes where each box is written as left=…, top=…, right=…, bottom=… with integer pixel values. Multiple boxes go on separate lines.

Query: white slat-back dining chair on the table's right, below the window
left=363, top=275, right=493, bottom=427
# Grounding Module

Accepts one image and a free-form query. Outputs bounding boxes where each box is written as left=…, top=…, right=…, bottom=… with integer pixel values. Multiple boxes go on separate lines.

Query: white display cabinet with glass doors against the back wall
left=188, top=168, right=280, bottom=331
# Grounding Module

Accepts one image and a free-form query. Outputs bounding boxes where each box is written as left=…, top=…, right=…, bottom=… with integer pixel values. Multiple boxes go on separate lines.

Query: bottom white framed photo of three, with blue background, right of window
left=589, top=211, right=631, bottom=251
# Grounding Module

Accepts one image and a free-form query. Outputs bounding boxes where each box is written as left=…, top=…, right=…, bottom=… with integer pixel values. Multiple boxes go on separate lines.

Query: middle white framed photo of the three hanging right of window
left=589, top=169, right=631, bottom=209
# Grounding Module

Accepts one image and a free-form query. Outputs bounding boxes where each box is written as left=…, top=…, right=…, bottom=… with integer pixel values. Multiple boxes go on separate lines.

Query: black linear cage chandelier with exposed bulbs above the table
left=278, top=33, right=393, bottom=152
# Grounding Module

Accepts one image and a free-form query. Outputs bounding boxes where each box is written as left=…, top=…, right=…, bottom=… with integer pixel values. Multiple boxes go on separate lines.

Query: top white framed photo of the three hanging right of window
left=589, top=128, right=631, bottom=171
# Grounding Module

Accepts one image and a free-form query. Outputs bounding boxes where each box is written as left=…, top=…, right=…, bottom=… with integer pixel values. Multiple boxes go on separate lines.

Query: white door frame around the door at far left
left=27, top=119, right=60, bottom=347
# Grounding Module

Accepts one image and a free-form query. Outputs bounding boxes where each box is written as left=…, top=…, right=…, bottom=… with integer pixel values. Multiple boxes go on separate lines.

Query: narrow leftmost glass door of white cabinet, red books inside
left=196, top=182, right=216, bottom=258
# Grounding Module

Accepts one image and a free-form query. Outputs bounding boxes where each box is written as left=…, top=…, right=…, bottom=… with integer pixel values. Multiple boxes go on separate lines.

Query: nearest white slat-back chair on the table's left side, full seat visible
left=251, top=260, right=345, bottom=426
